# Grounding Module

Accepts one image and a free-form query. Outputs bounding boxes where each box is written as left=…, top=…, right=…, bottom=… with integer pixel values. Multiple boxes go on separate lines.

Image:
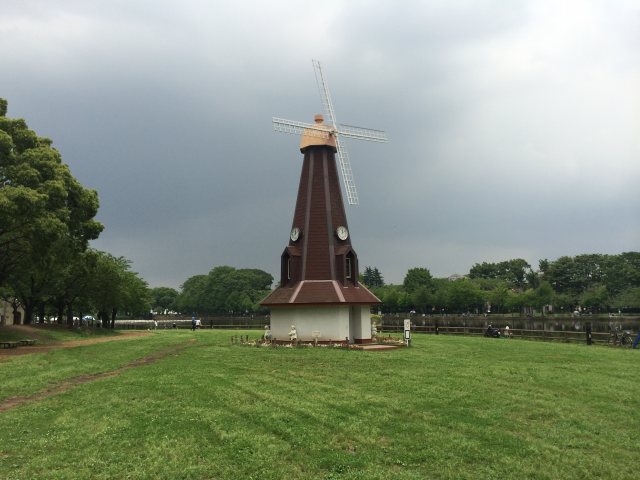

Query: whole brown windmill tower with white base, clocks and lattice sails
left=261, top=60, right=387, bottom=343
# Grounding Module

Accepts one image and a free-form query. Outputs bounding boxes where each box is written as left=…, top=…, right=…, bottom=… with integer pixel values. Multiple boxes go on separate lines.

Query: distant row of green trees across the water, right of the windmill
left=361, top=252, right=640, bottom=314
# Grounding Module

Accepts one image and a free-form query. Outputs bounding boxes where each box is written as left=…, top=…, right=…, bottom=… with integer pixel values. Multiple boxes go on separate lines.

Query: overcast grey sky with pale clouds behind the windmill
left=0, top=0, right=640, bottom=287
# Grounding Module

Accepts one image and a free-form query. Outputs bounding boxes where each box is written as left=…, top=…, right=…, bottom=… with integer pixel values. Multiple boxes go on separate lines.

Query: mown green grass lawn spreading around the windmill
left=0, top=330, right=640, bottom=480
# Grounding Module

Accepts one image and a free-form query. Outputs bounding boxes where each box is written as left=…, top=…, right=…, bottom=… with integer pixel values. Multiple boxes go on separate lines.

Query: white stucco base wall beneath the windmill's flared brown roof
left=271, top=305, right=371, bottom=342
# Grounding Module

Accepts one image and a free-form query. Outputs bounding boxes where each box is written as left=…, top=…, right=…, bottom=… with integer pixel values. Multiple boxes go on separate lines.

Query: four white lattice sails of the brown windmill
left=272, top=60, right=387, bottom=205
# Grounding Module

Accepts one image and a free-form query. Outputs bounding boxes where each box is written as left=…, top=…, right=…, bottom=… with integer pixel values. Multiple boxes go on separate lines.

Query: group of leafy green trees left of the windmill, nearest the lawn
left=0, top=99, right=150, bottom=327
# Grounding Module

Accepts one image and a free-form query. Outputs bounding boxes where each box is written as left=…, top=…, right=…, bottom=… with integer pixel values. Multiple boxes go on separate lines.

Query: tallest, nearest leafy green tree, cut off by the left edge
left=0, top=100, right=103, bottom=323
